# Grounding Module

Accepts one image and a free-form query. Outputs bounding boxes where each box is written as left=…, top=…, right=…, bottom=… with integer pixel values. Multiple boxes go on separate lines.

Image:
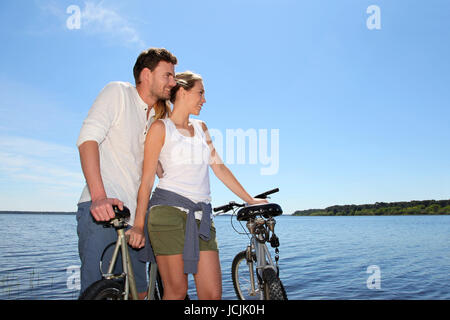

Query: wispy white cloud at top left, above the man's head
left=38, top=1, right=145, bottom=48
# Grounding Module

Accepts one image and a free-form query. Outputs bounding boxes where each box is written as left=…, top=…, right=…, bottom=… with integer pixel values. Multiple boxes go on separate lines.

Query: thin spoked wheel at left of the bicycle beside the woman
left=231, top=251, right=260, bottom=300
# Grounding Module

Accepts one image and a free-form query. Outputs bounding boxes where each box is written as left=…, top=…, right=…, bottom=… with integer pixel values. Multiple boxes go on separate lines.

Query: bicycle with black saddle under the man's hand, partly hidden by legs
left=79, top=206, right=164, bottom=300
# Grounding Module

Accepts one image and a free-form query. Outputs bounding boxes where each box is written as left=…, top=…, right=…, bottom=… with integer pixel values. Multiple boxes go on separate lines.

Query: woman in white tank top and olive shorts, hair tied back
left=129, top=71, right=267, bottom=300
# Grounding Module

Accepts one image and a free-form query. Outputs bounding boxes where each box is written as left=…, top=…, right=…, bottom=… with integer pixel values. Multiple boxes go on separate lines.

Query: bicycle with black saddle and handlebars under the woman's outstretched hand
left=214, top=188, right=287, bottom=300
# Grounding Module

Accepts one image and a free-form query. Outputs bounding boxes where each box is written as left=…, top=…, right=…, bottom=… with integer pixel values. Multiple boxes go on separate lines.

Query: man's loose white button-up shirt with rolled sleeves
left=77, top=82, right=155, bottom=225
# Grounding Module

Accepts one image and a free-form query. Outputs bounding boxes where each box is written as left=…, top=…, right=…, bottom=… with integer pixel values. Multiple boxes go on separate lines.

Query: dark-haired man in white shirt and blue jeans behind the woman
left=77, top=48, right=177, bottom=298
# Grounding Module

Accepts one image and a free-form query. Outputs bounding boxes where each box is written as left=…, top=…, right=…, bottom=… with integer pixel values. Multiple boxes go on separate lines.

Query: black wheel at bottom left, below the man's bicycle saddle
left=79, top=279, right=124, bottom=300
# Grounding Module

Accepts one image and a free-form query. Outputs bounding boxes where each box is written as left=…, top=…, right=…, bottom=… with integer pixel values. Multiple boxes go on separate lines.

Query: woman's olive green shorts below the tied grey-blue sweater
left=148, top=205, right=219, bottom=256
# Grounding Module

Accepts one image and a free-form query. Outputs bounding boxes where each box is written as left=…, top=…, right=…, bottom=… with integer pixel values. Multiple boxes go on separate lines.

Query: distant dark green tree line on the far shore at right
left=293, top=200, right=450, bottom=216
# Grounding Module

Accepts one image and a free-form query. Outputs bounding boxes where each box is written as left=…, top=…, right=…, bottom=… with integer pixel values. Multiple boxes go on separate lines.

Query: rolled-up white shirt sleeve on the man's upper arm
left=77, top=82, right=123, bottom=147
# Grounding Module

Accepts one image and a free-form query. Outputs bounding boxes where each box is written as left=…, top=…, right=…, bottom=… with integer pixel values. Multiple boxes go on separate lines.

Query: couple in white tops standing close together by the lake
left=77, top=48, right=267, bottom=300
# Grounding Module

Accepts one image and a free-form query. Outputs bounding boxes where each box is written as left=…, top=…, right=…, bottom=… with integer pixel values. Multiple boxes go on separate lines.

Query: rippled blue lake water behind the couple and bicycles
left=0, top=214, right=450, bottom=300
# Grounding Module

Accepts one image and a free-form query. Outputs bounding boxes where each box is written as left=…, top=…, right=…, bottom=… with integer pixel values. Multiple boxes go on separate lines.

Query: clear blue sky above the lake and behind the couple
left=0, top=0, right=450, bottom=213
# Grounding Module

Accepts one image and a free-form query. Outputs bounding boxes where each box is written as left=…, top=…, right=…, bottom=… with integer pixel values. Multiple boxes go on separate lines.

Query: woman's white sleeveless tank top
left=158, top=118, right=211, bottom=203
